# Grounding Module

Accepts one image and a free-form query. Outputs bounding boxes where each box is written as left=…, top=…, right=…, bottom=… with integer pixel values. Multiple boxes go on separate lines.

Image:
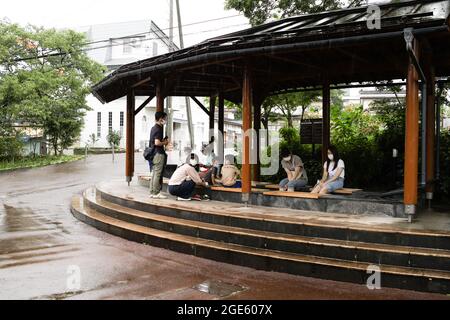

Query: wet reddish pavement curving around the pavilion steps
left=0, top=154, right=448, bottom=299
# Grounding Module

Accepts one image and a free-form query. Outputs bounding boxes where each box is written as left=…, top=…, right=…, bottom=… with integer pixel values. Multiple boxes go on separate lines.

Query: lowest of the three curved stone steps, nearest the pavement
left=71, top=196, right=450, bottom=293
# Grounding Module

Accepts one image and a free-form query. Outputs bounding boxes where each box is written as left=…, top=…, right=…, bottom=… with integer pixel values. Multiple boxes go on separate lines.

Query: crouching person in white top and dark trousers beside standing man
left=169, top=154, right=208, bottom=201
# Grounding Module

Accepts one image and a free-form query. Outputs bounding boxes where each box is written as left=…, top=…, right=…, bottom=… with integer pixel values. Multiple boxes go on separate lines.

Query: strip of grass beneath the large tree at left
left=0, top=155, right=84, bottom=172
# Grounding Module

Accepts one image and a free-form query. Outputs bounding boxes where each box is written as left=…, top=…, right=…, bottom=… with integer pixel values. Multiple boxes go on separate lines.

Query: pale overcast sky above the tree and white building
left=0, top=0, right=248, bottom=45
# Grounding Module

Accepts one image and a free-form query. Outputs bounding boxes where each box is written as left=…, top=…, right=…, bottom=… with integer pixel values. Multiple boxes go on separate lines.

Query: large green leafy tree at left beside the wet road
left=0, top=21, right=105, bottom=155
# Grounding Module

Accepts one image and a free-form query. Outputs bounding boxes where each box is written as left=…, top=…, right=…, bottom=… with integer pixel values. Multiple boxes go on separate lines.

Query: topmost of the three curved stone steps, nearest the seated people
left=95, top=185, right=450, bottom=250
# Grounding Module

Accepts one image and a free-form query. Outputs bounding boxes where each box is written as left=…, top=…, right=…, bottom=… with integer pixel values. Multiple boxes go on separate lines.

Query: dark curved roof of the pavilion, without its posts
left=93, top=0, right=450, bottom=102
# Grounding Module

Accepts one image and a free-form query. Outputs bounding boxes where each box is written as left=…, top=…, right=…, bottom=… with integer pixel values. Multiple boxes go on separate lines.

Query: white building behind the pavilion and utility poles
left=78, top=20, right=241, bottom=164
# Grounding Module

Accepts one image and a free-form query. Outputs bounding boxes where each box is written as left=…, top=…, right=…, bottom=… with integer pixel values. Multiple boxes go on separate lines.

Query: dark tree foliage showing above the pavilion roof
left=225, top=0, right=366, bottom=26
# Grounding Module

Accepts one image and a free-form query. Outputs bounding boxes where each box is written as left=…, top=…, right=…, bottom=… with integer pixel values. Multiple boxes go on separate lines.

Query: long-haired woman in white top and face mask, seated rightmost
left=311, top=146, right=345, bottom=194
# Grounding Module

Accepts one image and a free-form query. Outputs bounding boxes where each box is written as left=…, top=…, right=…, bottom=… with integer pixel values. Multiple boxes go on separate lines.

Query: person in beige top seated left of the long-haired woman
left=280, top=149, right=308, bottom=192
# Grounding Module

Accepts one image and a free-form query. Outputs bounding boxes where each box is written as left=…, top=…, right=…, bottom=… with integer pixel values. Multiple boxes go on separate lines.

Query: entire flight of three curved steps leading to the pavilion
left=71, top=187, right=450, bottom=293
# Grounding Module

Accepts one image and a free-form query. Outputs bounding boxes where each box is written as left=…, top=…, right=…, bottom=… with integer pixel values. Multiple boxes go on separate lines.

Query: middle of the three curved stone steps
left=83, top=189, right=450, bottom=270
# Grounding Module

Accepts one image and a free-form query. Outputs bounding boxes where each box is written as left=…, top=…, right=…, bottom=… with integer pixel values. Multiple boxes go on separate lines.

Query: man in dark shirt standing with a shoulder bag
left=150, top=111, right=169, bottom=199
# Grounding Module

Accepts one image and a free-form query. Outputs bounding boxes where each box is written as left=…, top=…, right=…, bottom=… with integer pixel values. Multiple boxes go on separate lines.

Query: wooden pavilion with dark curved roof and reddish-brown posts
left=93, top=0, right=450, bottom=221
